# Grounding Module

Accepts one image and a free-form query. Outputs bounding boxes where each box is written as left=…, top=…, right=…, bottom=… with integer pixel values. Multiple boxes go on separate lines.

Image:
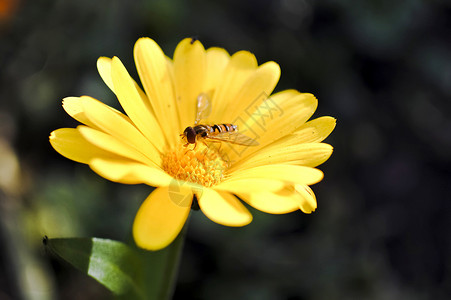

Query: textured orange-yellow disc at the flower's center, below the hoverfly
left=163, top=143, right=228, bottom=187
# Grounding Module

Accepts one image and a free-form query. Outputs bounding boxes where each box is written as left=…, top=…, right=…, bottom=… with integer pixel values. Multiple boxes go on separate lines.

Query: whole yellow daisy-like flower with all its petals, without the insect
left=50, top=38, right=335, bottom=250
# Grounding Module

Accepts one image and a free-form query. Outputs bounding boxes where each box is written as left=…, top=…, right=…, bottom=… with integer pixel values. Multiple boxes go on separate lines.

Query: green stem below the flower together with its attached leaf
left=43, top=219, right=187, bottom=300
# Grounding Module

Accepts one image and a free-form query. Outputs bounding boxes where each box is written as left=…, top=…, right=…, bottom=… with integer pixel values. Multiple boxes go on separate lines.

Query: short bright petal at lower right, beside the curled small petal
left=238, top=188, right=300, bottom=214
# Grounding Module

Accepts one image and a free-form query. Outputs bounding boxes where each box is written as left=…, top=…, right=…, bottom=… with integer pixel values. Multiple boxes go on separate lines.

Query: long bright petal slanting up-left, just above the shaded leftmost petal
left=80, top=96, right=161, bottom=165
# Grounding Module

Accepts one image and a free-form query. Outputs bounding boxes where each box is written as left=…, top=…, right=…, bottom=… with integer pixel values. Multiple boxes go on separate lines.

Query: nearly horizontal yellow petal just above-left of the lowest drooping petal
left=89, top=158, right=174, bottom=186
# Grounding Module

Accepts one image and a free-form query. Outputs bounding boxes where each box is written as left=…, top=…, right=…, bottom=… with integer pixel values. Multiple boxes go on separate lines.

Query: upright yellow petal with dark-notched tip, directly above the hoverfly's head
left=174, top=38, right=206, bottom=130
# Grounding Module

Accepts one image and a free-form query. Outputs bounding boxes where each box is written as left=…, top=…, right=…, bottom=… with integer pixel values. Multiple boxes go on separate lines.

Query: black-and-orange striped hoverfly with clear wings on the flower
left=180, top=93, right=258, bottom=148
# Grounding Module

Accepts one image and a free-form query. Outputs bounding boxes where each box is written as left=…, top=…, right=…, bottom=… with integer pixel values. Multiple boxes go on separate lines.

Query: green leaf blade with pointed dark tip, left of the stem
left=43, top=237, right=142, bottom=298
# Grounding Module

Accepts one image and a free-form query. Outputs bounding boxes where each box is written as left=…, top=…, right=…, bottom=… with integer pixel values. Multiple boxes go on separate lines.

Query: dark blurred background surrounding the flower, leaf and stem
left=0, top=0, right=451, bottom=300
